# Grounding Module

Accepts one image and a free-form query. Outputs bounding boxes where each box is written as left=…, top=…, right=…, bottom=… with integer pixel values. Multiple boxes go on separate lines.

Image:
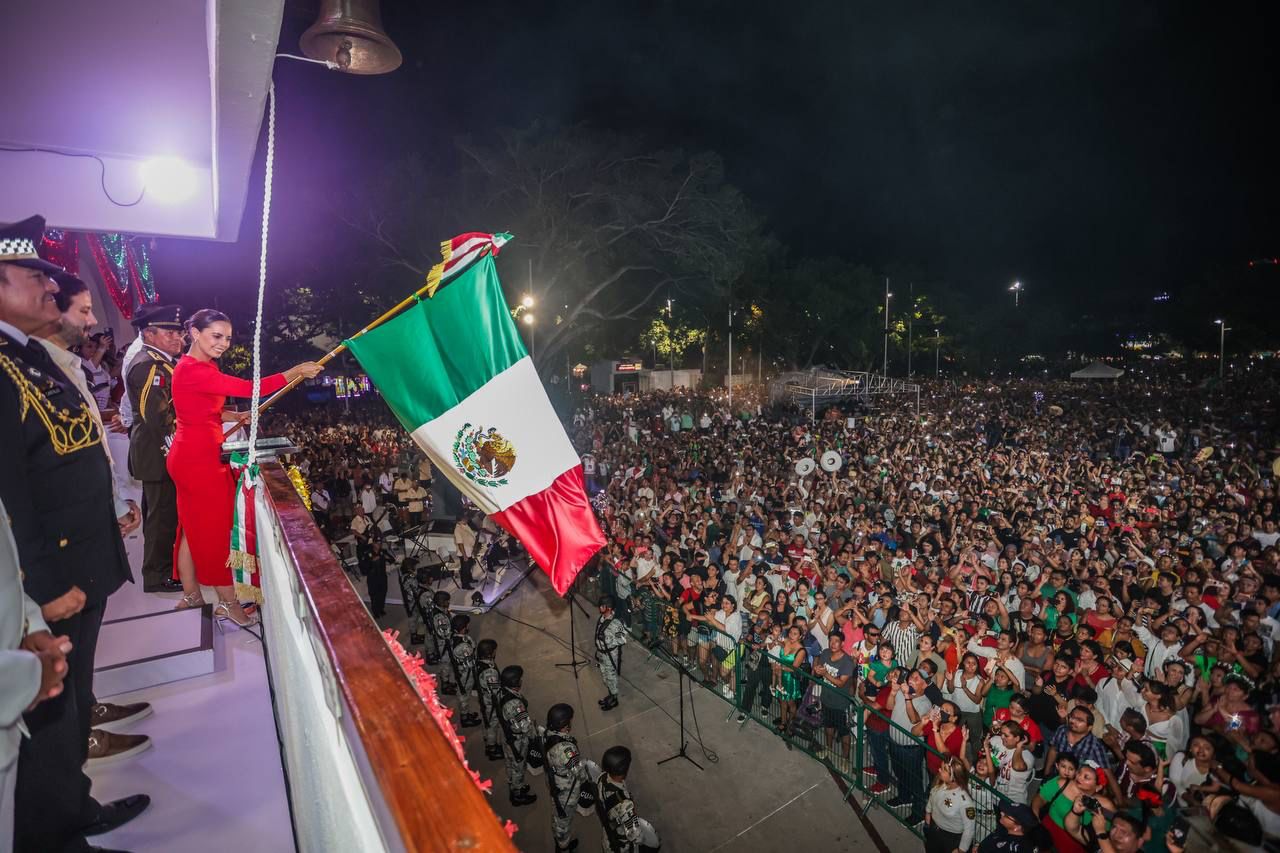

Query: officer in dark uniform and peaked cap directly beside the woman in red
left=125, top=305, right=182, bottom=592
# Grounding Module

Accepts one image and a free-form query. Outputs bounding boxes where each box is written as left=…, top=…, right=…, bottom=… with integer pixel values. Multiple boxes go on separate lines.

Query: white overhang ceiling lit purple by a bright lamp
left=0, top=0, right=284, bottom=240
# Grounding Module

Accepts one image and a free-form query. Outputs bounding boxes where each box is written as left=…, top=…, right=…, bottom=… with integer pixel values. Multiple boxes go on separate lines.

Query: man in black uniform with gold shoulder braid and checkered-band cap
left=0, top=216, right=150, bottom=853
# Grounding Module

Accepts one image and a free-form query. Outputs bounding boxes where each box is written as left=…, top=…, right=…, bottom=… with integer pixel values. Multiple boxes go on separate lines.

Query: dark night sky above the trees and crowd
left=157, top=0, right=1280, bottom=307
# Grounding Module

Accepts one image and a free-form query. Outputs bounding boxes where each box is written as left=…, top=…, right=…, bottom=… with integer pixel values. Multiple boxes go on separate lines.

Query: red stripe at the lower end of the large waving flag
left=490, top=465, right=604, bottom=596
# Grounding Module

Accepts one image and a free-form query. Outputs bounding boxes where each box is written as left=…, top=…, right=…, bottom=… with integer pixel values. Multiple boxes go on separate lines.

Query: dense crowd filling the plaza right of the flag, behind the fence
left=572, top=370, right=1280, bottom=852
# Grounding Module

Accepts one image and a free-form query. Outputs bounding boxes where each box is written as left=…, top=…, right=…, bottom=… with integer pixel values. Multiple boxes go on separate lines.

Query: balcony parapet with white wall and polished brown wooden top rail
left=260, top=462, right=516, bottom=853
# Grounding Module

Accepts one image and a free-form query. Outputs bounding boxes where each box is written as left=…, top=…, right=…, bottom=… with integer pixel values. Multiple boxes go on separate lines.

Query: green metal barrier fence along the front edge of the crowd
left=576, top=566, right=1009, bottom=845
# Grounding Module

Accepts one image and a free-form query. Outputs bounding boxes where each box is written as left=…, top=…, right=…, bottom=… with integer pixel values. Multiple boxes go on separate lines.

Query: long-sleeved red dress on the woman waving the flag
left=165, top=355, right=288, bottom=587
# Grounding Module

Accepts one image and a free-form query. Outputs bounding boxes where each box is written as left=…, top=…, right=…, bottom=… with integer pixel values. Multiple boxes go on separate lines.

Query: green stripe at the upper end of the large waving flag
left=346, top=256, right=526, bottom=432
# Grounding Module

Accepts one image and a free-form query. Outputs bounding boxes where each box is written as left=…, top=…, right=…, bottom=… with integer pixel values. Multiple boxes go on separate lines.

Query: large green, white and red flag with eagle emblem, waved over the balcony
left=346, top=243, right=604, bottom=594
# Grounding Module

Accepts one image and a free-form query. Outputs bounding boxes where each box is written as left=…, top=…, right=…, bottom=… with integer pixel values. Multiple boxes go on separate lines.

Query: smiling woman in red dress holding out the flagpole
left=165, top=309, right=324, bottom=626
